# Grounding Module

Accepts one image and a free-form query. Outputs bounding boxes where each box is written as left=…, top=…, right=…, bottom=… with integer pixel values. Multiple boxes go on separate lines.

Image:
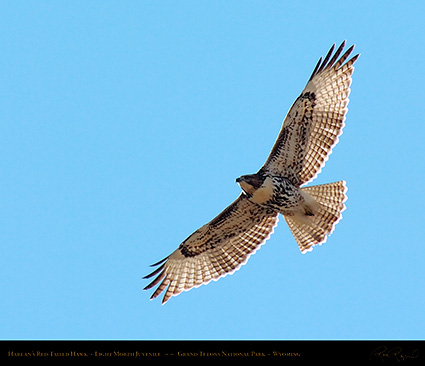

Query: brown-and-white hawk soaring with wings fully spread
left=144, top=41, right=359, bottom=304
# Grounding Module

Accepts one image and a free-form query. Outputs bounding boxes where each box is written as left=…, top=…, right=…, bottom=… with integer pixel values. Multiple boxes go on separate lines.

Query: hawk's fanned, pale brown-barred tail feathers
left=284, top=181, right=347, bottom=253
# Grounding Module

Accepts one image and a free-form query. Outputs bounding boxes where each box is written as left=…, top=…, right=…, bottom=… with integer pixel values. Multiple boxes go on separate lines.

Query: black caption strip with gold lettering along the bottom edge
left=1, top=340, right=425, bottom=365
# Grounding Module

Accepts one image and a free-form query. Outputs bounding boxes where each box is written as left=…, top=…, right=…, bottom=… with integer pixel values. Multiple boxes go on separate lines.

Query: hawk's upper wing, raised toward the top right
left=260, top=41, right=359, bottom=186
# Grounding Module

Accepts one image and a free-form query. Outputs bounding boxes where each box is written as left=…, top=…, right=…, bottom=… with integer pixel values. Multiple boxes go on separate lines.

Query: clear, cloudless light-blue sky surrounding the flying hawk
left=0, top=0, right=425, bottom=339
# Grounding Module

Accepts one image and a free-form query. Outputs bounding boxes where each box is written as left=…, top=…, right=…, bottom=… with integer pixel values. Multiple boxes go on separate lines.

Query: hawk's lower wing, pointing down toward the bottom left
left=144, top=193, right=278, bottom=304
